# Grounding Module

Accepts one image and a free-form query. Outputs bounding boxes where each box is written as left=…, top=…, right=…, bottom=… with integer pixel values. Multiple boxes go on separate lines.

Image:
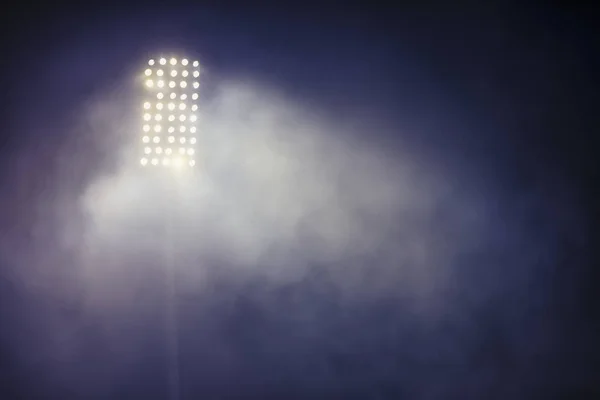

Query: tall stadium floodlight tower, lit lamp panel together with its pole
left=140, top=57, right=200, bottom=400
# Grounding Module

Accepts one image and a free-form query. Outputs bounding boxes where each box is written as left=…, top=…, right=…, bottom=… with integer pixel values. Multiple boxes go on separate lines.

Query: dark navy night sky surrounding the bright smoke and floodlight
left=0, top=4, right=600, bottom=400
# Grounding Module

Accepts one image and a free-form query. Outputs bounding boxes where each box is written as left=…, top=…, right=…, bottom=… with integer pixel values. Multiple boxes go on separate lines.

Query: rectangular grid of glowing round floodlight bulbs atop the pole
left=140, top=57, right=200, bottom=167
